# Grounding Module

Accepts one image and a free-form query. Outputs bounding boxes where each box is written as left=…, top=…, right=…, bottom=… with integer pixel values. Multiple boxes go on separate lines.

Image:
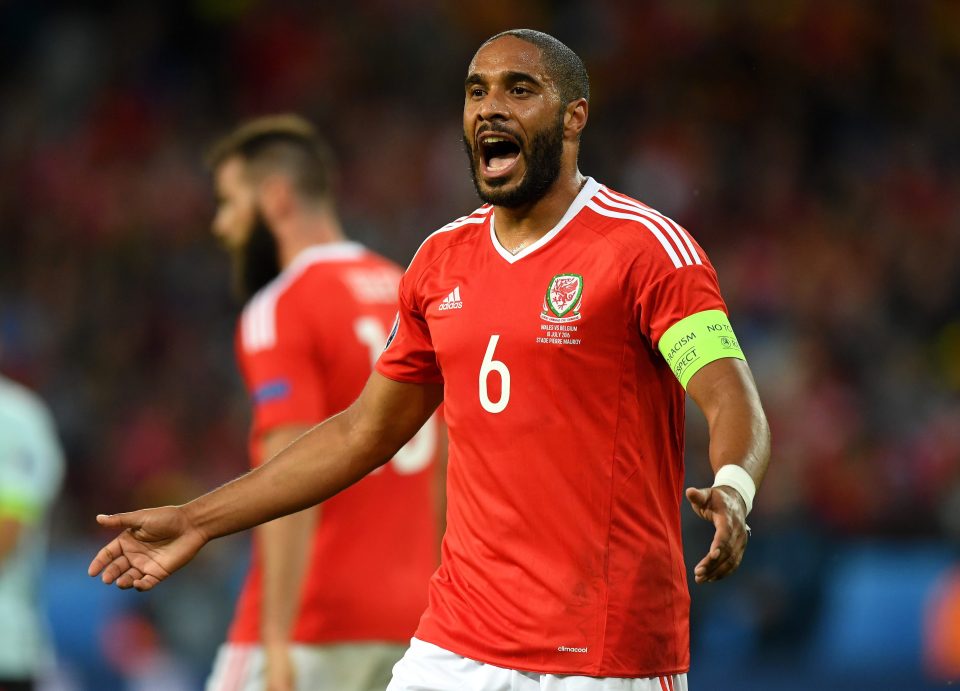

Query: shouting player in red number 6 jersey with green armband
left=90, top=30, right=770, bottom=691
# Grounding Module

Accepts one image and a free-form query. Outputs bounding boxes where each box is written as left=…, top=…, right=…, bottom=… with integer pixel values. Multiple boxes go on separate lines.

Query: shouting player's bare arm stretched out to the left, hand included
left=88, top=372, right=443, bottom=590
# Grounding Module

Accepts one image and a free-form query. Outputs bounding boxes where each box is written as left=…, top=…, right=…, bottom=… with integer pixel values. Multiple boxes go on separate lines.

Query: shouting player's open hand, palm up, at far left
left=87, top=506, right=207, bottom=590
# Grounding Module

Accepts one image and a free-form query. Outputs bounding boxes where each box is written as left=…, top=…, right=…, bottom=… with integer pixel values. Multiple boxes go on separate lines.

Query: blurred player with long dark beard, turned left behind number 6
left=207, top=115, right=445, bottom=691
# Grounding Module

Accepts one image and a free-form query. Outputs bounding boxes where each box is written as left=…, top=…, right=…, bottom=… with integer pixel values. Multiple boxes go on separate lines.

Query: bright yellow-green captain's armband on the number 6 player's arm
left=660, top=310, right=747, bottom=389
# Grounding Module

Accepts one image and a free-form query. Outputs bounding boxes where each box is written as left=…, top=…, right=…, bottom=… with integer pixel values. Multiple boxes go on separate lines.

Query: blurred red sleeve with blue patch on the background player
left=237, top=290, right=327, bottom=446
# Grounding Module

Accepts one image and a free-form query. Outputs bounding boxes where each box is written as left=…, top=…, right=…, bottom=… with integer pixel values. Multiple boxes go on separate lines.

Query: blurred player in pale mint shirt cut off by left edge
left=0, top=376, right=64, bottom=691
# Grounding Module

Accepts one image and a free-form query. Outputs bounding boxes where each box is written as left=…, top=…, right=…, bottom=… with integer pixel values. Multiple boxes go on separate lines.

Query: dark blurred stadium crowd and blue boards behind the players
left=0, top=0, right=960, bottom=691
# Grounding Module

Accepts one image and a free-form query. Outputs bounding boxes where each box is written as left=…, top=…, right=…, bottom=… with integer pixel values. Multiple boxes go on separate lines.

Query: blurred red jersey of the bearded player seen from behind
left=228, top=243, right=438, bottom=643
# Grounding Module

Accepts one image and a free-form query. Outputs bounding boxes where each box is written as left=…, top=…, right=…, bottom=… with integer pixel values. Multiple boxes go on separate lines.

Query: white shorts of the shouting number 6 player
left=387, top=638, right=687, bottom=691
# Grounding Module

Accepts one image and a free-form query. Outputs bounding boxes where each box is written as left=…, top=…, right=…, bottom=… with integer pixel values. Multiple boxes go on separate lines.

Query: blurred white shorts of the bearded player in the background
left=205, top=643, right=406, bottom=691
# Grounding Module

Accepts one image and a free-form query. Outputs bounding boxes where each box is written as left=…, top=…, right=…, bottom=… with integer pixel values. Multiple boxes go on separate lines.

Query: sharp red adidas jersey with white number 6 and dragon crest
left=377, top=178, right=726, bottom=677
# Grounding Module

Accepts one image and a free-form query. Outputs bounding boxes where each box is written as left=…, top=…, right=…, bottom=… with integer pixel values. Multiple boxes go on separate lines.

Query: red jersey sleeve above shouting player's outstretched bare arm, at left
left=376, top=266, right=443, bottom=384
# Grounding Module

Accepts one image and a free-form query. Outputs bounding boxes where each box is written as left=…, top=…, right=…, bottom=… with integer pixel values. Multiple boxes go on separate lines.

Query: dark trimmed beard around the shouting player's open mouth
left=463, top=111, right=563, bottom=209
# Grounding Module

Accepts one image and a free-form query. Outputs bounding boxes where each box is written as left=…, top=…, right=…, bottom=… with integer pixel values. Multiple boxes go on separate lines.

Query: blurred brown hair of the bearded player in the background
left=204, top=114, right=335, bottom=201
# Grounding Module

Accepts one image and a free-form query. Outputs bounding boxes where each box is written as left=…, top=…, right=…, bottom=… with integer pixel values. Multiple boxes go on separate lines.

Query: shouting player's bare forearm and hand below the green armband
left=686, top=358, right=770, bottom=583
